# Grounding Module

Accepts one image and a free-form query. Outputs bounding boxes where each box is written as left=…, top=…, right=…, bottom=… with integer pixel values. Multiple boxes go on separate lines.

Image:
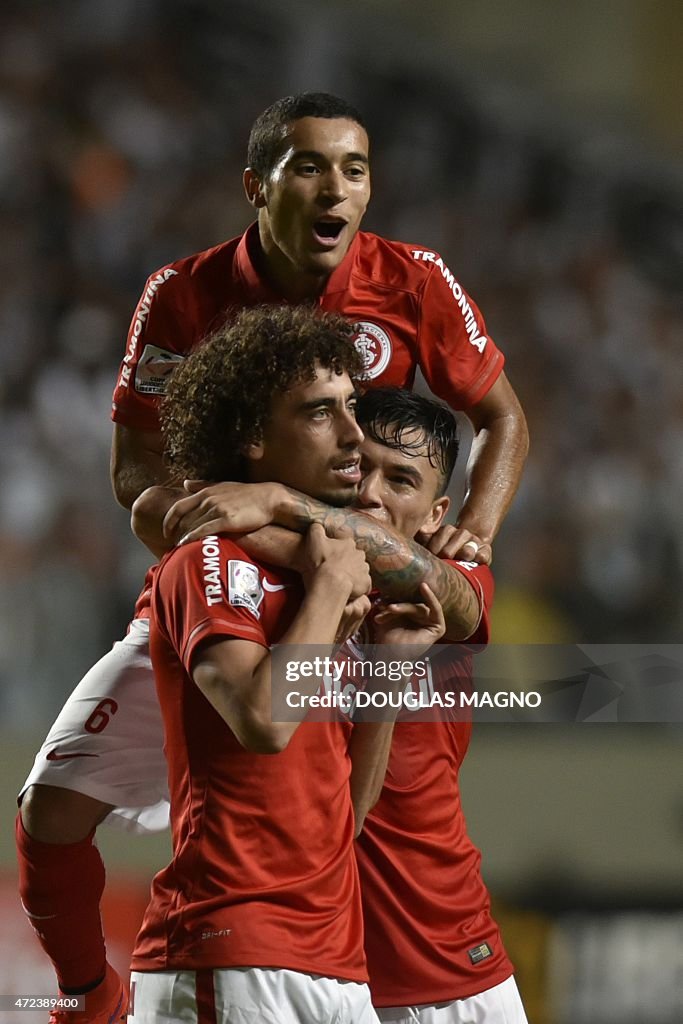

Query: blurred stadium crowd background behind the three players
left=0, top=0, right=683, bottom=1024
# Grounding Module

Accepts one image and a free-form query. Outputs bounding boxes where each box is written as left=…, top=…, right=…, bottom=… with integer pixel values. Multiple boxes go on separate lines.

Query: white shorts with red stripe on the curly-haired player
left=128, top=967, right=379, bottom=1024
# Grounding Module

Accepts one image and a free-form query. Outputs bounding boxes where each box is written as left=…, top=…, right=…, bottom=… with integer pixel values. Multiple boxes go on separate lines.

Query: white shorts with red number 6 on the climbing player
left=18, top=618, right=169, bottom=833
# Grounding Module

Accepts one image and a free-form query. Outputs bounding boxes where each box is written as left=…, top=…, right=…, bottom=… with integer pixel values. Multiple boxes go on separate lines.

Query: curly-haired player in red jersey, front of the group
left=128, top=307, right=385, bottom=1024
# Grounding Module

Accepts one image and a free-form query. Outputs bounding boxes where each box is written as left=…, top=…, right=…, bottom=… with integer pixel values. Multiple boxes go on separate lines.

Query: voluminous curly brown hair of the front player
left=160, top=306, right=362, bottom=481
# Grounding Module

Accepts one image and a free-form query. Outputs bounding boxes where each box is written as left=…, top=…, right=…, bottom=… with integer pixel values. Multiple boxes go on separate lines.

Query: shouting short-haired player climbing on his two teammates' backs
left=16, top=93, right=527, bottom=1024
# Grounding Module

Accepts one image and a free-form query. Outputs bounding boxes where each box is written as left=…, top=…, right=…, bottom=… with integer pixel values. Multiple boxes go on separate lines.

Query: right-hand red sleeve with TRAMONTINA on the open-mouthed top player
left=418, top=252, right=505, bottom=410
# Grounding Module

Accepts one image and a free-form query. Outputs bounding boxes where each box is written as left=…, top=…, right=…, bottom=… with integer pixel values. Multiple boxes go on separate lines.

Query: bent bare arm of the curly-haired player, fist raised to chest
left=193, top=524, right=371, bottom=754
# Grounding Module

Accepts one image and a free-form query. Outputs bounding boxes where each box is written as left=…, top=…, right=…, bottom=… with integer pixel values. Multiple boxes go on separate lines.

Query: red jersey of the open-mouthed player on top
left=112, top=224, right=504, bottom=430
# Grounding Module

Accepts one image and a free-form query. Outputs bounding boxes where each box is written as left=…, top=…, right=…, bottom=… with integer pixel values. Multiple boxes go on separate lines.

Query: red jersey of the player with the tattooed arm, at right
left=356, top=562, right=512, bottom=1007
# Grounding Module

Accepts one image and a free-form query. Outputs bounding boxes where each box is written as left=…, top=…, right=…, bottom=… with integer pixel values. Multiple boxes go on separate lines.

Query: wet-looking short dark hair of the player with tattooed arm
left=355, top=387, right=460, bottom=494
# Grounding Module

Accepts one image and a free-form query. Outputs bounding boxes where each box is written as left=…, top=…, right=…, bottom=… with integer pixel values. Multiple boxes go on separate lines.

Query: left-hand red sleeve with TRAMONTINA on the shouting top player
left=112, top=266, right=188, bottom=430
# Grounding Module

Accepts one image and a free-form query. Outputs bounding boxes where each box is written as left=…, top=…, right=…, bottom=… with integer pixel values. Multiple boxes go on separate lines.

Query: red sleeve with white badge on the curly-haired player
left=153, top=537, right=268, bottom=673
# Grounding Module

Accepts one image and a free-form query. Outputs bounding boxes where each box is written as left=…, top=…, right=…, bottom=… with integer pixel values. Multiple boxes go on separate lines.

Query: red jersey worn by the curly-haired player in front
left=133, top=537, right=368, bottom=981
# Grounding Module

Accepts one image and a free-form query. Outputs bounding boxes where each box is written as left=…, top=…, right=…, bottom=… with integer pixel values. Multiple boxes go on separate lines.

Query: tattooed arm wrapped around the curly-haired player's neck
left=275, top=492, right=479, bottom=640
